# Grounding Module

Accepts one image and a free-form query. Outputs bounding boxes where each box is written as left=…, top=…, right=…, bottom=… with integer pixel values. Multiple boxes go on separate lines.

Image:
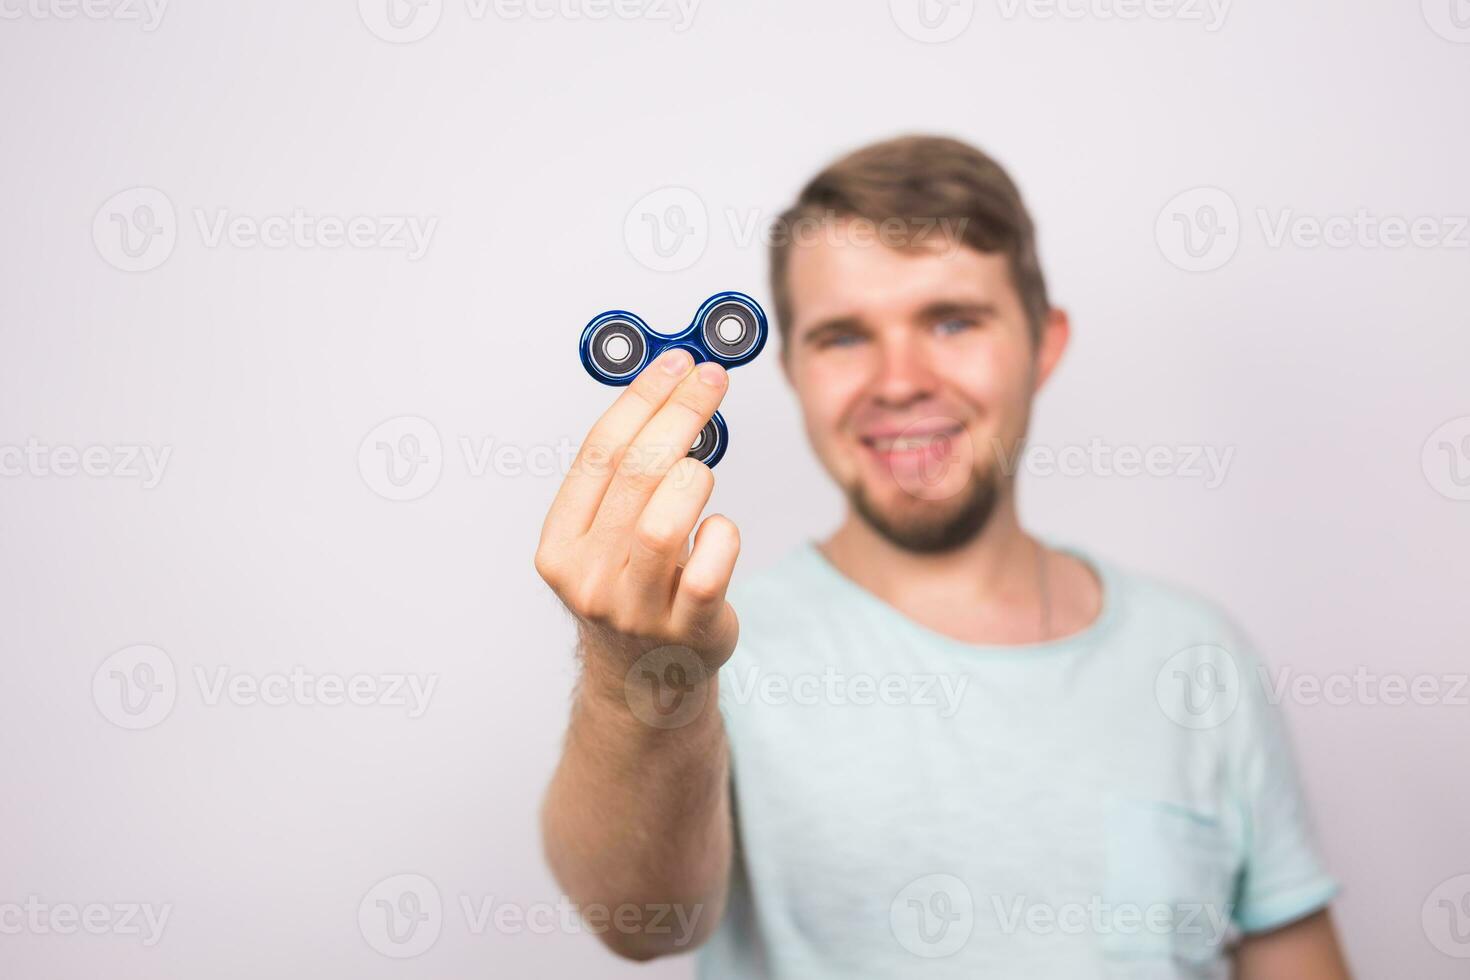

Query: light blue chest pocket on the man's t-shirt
left=1097, top=799, right=1241, bottom=977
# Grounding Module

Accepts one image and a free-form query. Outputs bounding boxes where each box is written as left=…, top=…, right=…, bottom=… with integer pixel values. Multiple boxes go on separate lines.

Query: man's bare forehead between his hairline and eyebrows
left=786, top=226, right=1019, bottom=329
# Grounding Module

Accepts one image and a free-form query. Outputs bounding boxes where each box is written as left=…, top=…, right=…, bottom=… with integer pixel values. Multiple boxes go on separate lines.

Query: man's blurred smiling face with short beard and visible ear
left=784, top=221, right=1067, bottom=552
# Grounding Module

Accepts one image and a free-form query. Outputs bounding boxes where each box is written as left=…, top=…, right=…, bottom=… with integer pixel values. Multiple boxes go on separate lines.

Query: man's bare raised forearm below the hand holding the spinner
left=542, top=658, right=732, bottom=959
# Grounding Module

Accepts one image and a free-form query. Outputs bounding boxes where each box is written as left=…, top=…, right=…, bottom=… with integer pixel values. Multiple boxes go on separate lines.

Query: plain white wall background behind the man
left=0, top=0, right=1470, bottom=980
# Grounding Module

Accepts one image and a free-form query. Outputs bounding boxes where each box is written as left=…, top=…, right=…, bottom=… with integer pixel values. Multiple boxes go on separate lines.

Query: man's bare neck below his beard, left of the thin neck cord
left=820, top=492, right=1039, bottom=608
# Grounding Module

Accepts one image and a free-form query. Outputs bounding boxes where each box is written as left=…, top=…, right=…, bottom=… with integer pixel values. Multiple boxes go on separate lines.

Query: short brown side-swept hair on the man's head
left=770, top=135, right=1051, bottom=345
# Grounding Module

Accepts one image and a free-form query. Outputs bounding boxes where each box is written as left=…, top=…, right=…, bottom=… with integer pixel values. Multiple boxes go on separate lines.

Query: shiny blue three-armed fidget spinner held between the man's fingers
left=581, top=292, right=770, bottom=466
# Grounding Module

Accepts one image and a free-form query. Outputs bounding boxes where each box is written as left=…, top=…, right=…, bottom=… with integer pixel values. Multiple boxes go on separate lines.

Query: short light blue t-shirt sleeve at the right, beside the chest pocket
left=1229, top=630, right=1338, bottom=933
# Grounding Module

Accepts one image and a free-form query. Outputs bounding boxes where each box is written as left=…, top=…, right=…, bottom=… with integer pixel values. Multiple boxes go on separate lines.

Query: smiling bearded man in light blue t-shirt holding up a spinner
left=537, top=138, right=1347, bottom=980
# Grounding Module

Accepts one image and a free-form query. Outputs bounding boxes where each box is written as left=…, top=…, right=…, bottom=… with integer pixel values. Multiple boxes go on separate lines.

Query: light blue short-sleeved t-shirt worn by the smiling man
left=700, top=547, right=1336, bottom=980
